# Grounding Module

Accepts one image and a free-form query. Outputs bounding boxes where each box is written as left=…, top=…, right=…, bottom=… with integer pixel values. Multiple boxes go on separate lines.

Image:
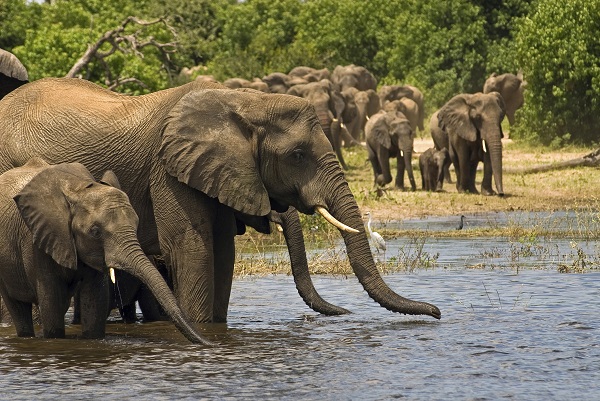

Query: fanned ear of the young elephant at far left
left=14, top=163, right=94, bottom=269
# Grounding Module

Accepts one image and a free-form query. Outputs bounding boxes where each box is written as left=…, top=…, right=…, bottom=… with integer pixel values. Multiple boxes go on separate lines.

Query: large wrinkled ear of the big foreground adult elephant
left=160, top=89, right=271, bottom=216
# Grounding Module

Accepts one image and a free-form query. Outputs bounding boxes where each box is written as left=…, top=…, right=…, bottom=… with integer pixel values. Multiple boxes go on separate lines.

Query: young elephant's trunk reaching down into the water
left=106, top=239, right=214, bottom=345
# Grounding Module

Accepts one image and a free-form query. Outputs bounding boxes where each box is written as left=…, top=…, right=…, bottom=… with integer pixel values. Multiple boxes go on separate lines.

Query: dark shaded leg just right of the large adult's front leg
left=213, top=205, right=237, bottom=323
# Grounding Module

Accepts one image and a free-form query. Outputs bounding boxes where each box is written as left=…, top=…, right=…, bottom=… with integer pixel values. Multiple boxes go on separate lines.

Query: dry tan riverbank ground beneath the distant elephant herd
left=236, top=138, right=600, bottom=275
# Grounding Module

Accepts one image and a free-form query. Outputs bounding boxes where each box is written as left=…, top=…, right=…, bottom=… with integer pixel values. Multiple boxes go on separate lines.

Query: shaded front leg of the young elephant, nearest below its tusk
left=78, top=268, right=109, bottom=338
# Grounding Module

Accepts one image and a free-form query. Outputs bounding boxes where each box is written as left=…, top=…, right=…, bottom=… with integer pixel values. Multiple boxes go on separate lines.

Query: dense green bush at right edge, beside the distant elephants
left=514, top=0, right=600, bottom=146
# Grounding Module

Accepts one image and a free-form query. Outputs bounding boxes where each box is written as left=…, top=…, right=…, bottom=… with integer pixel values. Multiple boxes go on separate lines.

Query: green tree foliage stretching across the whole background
left=0, top=0, right=600, bottom=144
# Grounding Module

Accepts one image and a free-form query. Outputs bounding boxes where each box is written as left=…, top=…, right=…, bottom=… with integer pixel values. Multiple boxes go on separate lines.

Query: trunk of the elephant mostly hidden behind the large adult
left=271, top=207, right=350, bottom=316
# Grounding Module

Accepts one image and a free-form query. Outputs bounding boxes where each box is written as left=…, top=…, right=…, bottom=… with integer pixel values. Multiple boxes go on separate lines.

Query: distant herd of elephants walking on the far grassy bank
left=206, top=65, right=526, bottom=196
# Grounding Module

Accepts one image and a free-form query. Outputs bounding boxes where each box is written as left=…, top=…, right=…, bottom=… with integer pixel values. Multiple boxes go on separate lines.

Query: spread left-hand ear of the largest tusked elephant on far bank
left=438, top=94, right=477, bottom=142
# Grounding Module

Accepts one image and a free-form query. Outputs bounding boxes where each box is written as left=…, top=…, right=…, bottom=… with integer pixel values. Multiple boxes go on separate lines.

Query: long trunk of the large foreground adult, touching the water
left=319, top=157, right=441, bottom=319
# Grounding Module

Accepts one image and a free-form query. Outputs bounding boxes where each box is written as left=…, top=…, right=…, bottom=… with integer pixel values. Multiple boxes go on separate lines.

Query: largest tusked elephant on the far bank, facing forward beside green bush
left=438, top=92, right=504, bottom=196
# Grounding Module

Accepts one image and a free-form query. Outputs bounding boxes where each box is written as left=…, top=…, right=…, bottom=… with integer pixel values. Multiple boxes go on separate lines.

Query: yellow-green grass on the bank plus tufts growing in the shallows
left=236, top=138, right=600, bottom=275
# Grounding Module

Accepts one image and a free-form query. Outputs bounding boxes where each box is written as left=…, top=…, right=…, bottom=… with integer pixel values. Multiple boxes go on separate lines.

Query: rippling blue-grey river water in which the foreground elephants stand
left=0, top=211, right=600, bottom=400
